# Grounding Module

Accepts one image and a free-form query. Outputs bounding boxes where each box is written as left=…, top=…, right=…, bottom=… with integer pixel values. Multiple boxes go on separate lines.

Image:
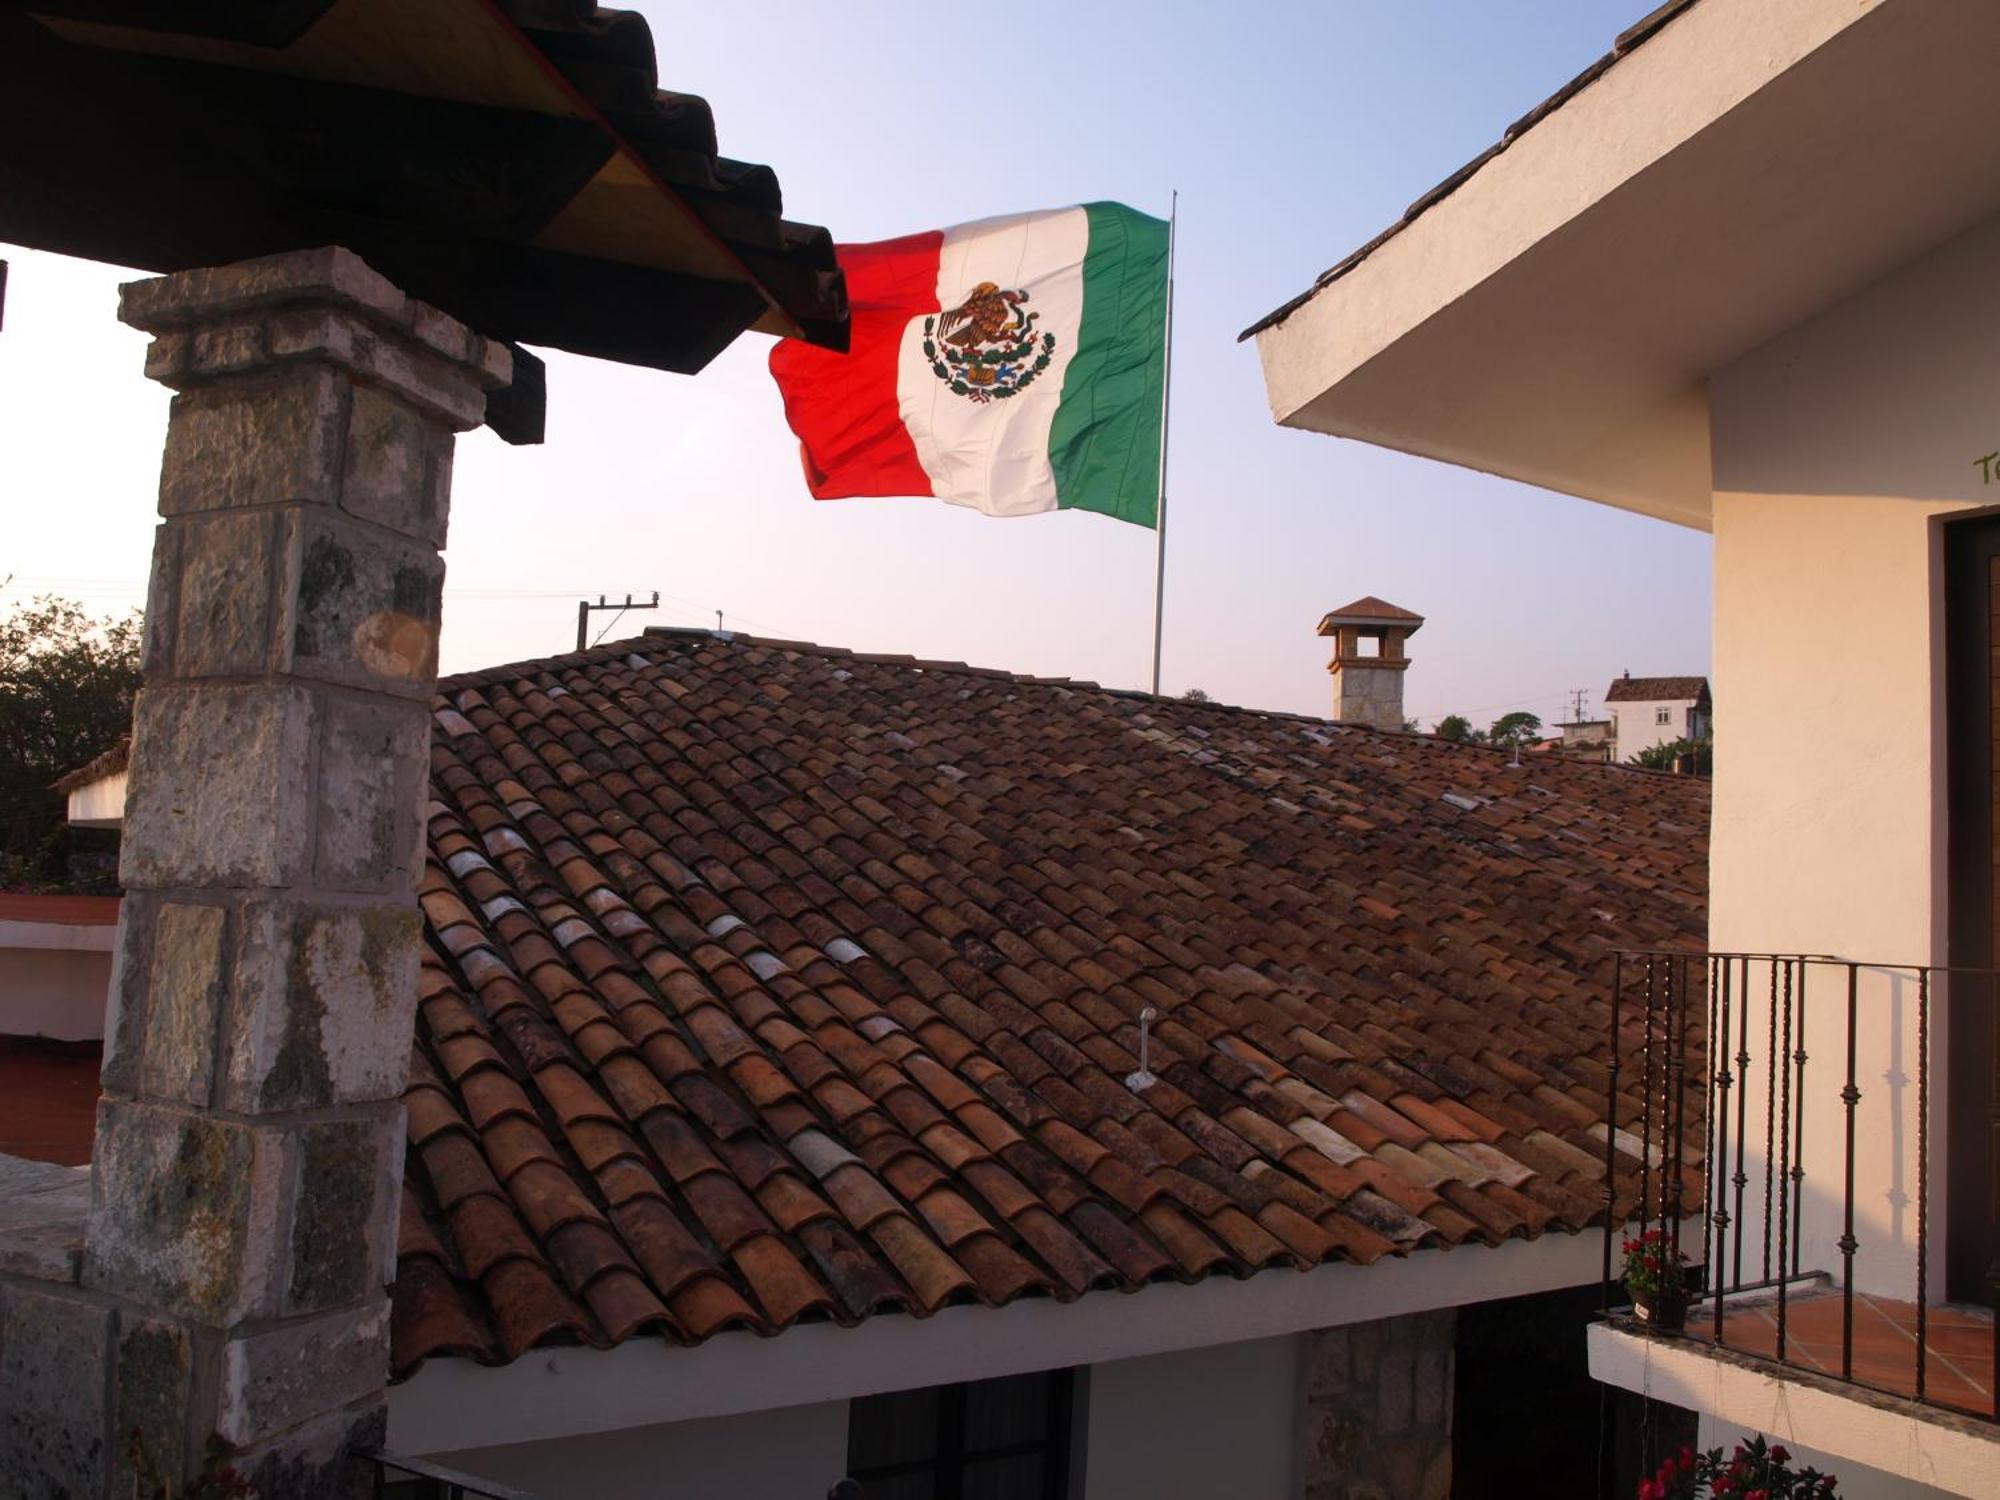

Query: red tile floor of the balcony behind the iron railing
left=1688, top=1288, right=1994, bottom=1416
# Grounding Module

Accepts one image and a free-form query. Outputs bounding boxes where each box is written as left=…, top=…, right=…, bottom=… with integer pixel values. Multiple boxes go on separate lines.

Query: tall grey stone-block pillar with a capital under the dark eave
left=18, top=248, right=510, bottom=1498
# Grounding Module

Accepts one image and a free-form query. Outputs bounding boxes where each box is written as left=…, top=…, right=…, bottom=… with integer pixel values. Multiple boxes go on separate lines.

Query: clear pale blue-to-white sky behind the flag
left=0, top=0, right=1710, bottom=724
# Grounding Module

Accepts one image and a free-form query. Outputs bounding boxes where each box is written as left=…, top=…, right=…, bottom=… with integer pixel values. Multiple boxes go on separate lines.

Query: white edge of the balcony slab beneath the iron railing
left=1588, top=1324, right=2000, bottom=1500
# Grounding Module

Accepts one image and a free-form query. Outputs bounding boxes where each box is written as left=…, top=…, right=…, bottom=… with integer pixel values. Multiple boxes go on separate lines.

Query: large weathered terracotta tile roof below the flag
left=394, top=632, right=1708, bottom=1376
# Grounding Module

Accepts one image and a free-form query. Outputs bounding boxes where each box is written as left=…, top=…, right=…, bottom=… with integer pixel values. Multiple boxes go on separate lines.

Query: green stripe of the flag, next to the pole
left=1048, top=204, right=1166, bottom=526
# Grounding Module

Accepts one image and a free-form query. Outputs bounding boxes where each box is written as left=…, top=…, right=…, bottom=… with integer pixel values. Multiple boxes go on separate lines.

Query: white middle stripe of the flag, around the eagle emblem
left=896, top=208, right=1090, bottom=516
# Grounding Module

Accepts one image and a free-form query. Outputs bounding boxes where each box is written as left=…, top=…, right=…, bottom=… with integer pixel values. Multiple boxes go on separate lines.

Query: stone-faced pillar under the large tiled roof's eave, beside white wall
left=1302, top=1308, right=1458, bottom=1500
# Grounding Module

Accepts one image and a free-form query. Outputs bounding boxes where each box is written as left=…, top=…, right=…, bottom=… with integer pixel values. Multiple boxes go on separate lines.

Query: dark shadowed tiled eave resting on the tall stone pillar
left=0, top=0, right=848, bottom=412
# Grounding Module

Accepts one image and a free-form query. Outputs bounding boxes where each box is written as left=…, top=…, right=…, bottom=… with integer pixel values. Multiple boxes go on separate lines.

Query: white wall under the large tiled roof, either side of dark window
left=424, top=1336, right=1300, bottom=1500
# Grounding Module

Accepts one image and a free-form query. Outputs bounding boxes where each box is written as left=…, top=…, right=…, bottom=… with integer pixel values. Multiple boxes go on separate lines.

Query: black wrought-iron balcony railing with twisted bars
left=1604, top=952, right=2000, bottom=1420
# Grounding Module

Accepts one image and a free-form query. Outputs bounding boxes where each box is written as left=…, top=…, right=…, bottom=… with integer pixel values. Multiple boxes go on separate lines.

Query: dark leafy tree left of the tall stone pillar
left=0, top=598, right=140, bottom=890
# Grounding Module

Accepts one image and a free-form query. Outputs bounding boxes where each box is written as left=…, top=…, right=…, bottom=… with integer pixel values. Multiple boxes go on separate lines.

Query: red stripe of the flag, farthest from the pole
left=770, top=230, right=944, bottom=500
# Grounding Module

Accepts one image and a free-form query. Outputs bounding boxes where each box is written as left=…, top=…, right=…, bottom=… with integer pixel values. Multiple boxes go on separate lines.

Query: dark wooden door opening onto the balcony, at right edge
left=1944, top=516, right=2000, bottom=1304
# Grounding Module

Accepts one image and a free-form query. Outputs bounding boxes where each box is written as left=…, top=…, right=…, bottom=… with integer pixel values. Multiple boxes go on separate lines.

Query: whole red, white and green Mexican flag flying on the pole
left=770, top=204, right=1166, bottom=526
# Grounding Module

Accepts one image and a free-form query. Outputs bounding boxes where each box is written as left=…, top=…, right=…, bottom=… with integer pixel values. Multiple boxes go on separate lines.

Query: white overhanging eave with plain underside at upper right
left=1250, top=0, right=2000, bottom=528
